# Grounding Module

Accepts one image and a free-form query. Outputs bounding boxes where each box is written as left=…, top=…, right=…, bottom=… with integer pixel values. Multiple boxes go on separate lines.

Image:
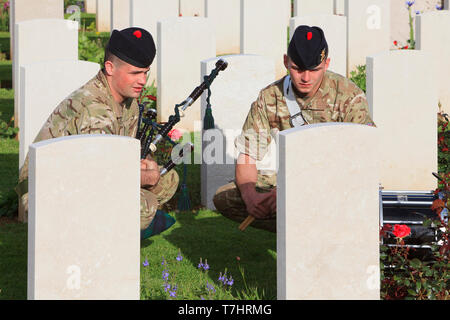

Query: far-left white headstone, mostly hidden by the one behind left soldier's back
left=13, top=19, right=78, bottom=131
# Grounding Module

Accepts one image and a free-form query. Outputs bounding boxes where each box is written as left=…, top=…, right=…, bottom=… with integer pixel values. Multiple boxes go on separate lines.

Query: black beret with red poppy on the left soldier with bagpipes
left=106, top=27, right=156, bottom=68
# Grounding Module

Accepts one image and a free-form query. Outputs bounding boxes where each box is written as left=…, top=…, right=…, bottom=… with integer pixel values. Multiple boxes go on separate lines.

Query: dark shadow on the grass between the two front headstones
left=146, top=210, right=276, bottom=299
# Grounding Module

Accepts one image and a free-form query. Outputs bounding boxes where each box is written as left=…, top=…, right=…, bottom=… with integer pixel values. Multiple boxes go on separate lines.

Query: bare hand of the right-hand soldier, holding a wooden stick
left=243, top=189, right=277, bottom=219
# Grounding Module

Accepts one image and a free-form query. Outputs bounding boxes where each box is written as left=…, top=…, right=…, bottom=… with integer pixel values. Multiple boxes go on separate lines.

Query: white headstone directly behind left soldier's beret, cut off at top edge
left=130, top=0, right=178, bottom=86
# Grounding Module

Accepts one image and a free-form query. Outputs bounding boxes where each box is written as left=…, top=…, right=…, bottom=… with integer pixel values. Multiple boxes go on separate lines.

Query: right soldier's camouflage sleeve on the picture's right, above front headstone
left=343, top=85, right=376, bottom=127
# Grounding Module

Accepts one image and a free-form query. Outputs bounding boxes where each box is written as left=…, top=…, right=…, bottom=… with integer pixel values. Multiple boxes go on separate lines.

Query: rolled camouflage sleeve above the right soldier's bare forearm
left=234, top=93, right=272, bottom=161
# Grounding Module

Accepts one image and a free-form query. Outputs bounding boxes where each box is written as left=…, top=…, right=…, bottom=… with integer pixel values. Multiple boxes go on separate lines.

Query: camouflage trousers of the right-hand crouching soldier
left=213, top=172, right=277, bottom=232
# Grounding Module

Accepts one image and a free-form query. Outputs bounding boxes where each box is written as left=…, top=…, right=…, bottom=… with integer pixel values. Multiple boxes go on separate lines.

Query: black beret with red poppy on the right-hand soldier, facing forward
left=288, top=26, right=328, bottom=70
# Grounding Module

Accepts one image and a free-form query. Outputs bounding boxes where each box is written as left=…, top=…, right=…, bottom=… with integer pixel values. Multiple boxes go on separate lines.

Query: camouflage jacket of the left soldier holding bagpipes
left=16, top=70, right=139, bottom=195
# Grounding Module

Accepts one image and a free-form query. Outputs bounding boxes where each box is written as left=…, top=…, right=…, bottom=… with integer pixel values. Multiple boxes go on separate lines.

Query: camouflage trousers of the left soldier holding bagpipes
left=19, top=170, right=179, bottom=230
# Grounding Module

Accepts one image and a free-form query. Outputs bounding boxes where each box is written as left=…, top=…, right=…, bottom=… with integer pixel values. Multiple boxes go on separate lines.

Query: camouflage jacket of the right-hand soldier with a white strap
left=235, top=71, right=375, bottom=160
